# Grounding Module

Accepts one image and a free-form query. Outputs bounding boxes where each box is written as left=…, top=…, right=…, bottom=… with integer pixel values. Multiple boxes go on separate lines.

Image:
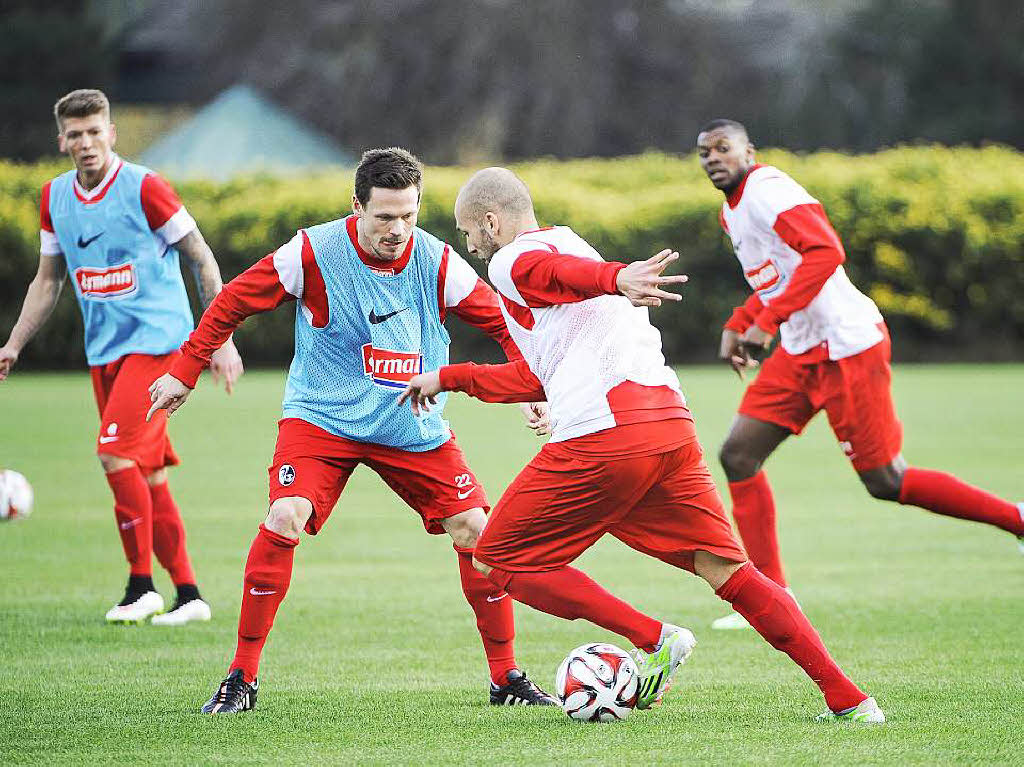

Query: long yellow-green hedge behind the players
left=0, top=145, right=1024, bottom=368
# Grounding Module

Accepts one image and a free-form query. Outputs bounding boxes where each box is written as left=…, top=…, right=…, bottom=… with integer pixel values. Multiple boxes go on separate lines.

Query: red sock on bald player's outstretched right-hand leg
left=715, top=562, right=867, bottom=712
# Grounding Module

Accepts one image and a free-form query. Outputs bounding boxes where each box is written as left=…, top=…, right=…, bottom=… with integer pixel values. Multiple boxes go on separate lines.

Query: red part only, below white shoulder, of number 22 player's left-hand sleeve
left=170, top=253, right=296, bottom=388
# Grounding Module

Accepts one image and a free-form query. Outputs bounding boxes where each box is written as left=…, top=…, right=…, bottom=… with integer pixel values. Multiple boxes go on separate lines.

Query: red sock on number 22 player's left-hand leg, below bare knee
left=230, top=524, right=299, bottom=683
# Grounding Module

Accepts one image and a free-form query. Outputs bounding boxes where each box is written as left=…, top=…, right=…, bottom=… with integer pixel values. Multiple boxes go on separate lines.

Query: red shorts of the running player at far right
left=739, top=326, right=903, bottom=472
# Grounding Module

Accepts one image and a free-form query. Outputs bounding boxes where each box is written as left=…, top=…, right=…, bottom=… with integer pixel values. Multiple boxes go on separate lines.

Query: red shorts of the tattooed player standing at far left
left=89, top=350, right=180, bottom=474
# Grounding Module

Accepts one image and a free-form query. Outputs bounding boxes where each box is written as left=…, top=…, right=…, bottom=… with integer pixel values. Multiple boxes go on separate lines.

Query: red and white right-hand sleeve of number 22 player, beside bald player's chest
left=437, top=247, right=522, bottom=359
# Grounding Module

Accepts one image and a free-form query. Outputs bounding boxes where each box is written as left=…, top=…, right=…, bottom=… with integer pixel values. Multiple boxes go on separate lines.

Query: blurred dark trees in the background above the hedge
left=0, top=0, right=1024, bottom=164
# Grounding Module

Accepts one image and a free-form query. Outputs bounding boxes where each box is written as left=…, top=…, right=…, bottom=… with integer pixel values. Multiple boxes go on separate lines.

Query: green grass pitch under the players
left=0, top=366, right=1024, bottom=765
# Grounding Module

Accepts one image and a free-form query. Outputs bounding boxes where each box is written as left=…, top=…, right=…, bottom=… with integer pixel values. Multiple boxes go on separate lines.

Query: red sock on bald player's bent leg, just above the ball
left=488, top=567, right=662, bottom=652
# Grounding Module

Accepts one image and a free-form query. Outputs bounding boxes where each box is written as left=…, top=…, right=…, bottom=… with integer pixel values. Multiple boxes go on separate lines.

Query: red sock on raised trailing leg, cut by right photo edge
left=899, top=466, right=1024, bottom=536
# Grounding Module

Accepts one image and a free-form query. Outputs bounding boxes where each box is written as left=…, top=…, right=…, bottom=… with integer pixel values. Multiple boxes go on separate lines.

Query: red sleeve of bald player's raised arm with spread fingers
left=511, top=250, right=626, bottom=308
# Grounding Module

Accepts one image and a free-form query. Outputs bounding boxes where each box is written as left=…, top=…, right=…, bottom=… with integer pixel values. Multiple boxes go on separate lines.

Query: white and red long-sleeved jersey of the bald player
left=441, top=226, right=691, bottom=442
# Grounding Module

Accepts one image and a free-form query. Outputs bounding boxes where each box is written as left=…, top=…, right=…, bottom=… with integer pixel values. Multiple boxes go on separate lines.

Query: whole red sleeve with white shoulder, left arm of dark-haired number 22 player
left=170, top=231, right=319, bottom=388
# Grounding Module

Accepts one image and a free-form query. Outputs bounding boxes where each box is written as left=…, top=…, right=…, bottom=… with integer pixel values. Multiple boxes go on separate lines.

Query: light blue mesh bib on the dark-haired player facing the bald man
left=284, top=218, right=451, bottom=452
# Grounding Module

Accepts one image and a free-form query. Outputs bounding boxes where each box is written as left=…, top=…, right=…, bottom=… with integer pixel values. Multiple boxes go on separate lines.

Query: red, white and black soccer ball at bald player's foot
left=555, top=644, right=640, bottom=722
